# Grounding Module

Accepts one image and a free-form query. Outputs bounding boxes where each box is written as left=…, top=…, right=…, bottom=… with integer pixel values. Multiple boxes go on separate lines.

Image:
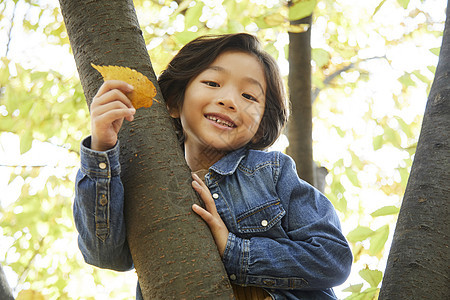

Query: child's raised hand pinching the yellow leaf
left=91, top=80, right=136, bottom=151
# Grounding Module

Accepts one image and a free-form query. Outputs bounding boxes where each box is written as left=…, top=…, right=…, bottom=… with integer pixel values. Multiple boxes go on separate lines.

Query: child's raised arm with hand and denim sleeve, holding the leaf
left=74, top=81, right=135, bottom=271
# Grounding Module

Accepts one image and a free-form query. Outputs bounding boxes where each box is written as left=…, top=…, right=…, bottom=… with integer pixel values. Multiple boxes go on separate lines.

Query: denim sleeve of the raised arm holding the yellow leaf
left=73, top=137, right=133, bottom=271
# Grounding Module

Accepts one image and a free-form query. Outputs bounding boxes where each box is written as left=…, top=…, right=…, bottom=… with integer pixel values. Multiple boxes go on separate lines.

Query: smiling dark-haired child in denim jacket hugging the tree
left=74, top=34, right=352, bottom=299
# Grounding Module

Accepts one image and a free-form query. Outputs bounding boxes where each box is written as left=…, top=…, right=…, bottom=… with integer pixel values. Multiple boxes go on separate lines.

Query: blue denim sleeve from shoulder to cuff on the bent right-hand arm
left=223, top=153, right=352, bottom=290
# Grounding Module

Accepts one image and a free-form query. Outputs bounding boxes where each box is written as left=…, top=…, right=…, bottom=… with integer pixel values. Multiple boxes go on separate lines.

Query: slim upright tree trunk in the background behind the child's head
left=287, top=16, right=315, bottom=185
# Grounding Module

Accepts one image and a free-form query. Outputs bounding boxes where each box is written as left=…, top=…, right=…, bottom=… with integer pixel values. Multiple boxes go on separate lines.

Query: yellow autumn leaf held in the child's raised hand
left=91, top=63, right=158, bottom=109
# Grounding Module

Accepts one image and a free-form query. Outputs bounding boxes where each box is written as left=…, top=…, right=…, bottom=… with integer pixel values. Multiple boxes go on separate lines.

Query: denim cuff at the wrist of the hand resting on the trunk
left=222, top=232, right=250, bottom=285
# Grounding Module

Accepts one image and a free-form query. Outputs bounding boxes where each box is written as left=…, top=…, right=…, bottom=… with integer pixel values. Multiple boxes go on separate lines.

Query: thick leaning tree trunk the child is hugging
left=60, top=0, right=233, bottom=299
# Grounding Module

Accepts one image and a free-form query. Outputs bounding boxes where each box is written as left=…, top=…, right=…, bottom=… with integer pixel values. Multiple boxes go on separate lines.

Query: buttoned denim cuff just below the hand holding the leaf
left=80, top=136, right=120, bottom=178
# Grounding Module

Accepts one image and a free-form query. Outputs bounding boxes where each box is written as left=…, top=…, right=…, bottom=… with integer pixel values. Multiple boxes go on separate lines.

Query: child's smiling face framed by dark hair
left=171, top=51, right=266, bottom=152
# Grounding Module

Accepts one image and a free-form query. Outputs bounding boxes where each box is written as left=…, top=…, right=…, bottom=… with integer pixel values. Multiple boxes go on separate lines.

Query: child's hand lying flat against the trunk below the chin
left=192, top=174, right=228, bottom=257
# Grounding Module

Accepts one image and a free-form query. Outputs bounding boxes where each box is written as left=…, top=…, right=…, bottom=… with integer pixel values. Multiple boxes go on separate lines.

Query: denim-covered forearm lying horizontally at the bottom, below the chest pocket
left=223, top=233, right=352, bottom=290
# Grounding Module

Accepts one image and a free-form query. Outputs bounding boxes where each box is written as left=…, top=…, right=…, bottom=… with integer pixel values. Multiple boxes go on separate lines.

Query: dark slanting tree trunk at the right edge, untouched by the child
left=379, top=4, right=450, bottom=300
